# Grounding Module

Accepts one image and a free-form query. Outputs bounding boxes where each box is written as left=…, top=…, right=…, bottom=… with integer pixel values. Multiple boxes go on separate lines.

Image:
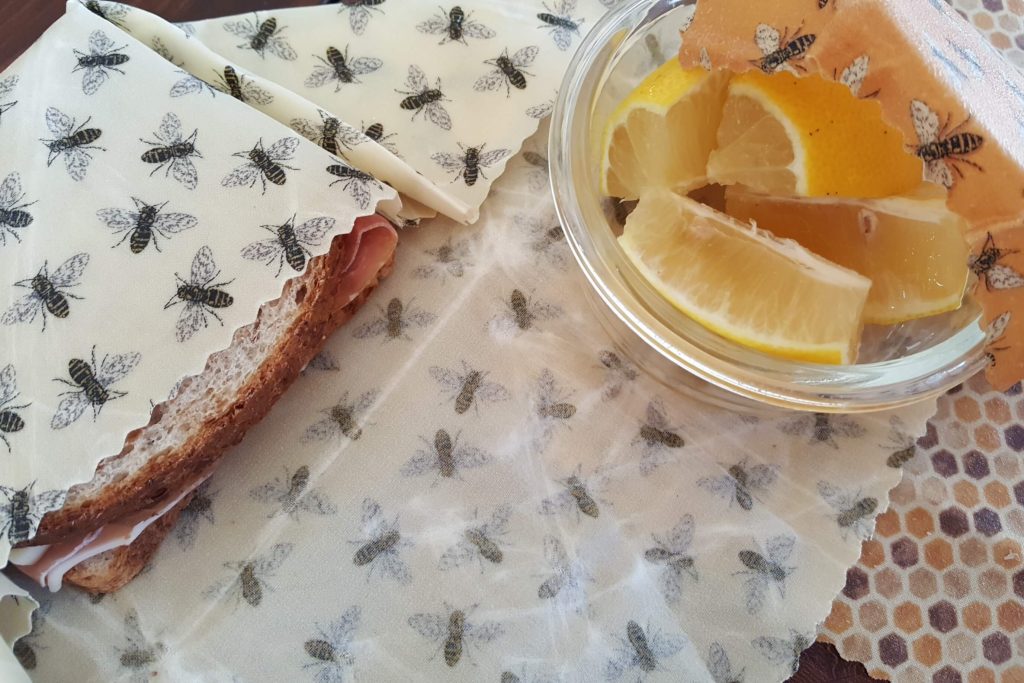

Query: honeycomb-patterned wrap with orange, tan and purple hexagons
left=821, top=368, right=1024, bottom=683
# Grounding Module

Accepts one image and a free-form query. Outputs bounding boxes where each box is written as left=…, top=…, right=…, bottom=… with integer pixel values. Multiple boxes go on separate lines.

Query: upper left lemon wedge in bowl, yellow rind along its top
left=601, top=58, right=729, bottom=200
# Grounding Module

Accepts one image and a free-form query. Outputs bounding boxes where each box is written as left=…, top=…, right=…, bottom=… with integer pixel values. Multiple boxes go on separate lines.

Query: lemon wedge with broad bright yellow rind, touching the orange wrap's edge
left=708, top=71, right=923, bottom=199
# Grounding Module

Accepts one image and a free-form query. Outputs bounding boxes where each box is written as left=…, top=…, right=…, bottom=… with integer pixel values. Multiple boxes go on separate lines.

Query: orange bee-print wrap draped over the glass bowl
left=681, top=0, right=1024, bottom=389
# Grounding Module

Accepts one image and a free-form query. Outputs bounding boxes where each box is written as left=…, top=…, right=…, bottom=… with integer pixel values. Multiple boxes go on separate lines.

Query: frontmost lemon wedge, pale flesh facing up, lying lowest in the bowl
left=618, top=189, right=871, bottom=364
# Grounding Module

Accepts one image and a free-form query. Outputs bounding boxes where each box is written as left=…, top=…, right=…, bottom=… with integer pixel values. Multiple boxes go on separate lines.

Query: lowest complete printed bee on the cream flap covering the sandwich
left=50, top=346, right=142, bottom=429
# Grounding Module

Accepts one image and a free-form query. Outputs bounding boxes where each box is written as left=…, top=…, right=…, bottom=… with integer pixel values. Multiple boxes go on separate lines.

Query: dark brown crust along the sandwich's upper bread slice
left=26, top=227, right=393, bottom=548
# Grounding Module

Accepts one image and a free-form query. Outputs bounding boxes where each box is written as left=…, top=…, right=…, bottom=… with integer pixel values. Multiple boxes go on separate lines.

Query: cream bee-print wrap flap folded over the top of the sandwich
left=0, top=3, right=397, bottom=563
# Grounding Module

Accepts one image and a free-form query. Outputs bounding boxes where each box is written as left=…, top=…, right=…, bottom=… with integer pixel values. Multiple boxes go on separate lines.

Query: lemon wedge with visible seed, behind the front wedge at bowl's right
left=725, top=187, right=969, bottom=325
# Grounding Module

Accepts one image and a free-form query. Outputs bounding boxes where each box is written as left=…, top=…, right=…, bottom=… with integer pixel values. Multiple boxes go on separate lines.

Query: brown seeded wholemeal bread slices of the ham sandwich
left=20, top=217, right=397, bottom=592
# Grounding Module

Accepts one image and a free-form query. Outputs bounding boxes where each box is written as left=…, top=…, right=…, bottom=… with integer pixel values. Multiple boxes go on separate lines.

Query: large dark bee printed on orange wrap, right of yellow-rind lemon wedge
left=910, top=99, right=985, bottom=188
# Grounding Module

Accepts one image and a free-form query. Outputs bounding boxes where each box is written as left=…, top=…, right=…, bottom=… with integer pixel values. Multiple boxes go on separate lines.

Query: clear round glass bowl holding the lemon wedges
left=548, top=0, right=987, bottom=413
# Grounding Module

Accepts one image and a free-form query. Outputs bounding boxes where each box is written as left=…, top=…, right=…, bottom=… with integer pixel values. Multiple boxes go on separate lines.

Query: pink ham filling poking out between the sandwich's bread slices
left=10, top=214, right=398, bottom=591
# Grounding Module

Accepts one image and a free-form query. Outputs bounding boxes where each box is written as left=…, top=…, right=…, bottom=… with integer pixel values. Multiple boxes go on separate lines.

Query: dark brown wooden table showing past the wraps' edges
left=0, top=0, right=874, bottom=683
